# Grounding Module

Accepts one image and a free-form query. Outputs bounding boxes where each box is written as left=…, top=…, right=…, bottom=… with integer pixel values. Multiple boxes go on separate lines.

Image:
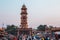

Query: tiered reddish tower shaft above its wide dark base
left=20, top=5, right=28, bottom=28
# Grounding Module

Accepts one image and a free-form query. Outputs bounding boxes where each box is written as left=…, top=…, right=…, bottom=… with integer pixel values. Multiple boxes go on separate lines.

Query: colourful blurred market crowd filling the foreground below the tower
left=0, top=33, right=57, bottom=40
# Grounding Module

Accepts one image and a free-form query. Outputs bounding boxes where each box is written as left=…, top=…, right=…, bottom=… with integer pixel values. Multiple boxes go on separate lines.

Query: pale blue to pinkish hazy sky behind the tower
left=0, top=0, right=60, bottom=28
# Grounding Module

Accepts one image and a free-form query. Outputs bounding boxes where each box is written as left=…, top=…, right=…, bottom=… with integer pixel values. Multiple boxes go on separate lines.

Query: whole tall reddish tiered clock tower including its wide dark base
left=18, top=5, right=32, bottom=35
